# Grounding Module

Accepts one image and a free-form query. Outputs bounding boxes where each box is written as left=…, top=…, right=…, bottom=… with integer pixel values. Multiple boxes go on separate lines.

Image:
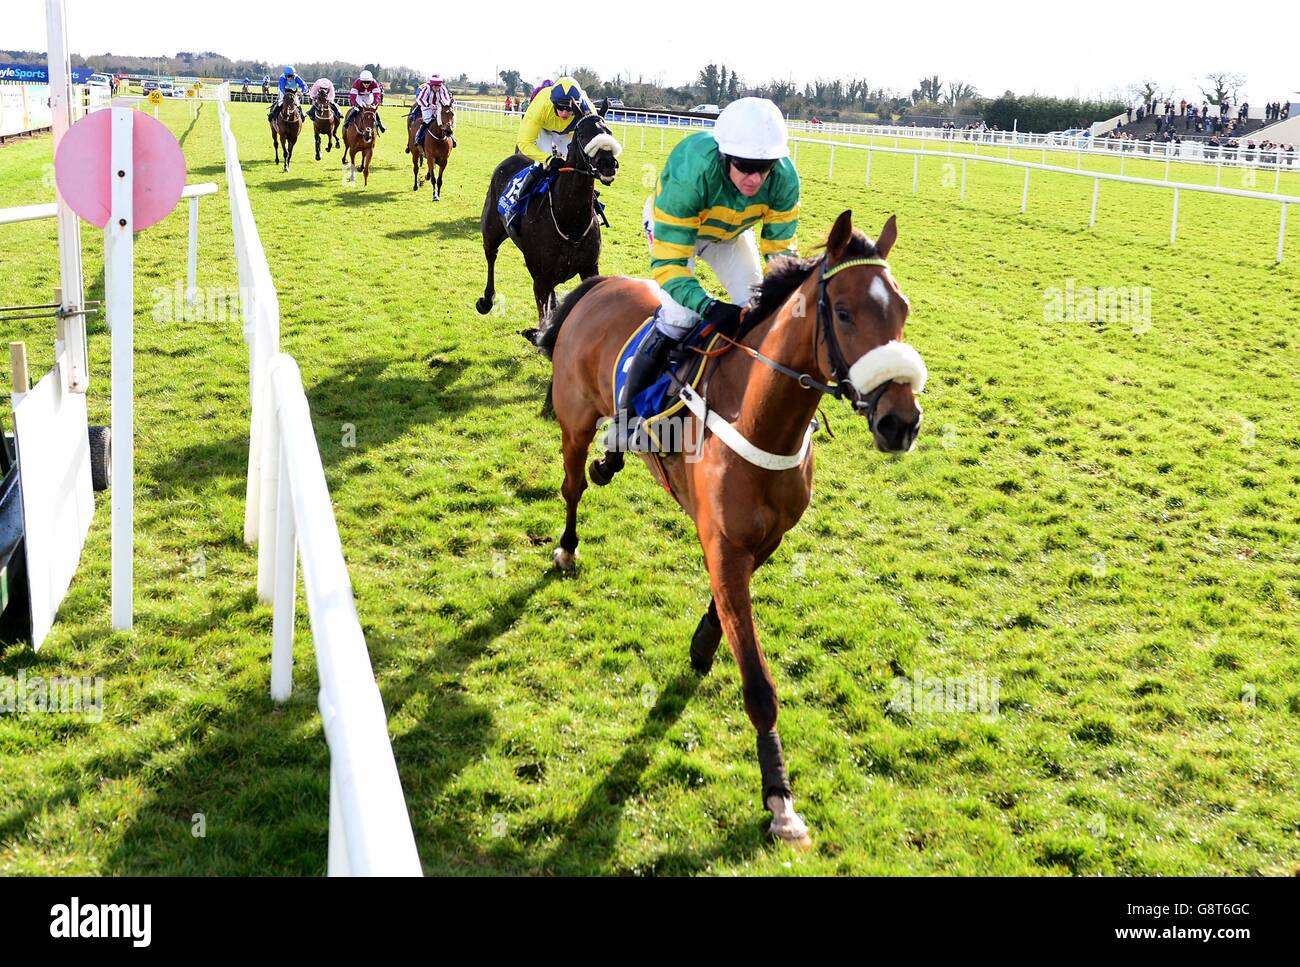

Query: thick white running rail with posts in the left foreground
left=217, top=101, right=421, bottom=876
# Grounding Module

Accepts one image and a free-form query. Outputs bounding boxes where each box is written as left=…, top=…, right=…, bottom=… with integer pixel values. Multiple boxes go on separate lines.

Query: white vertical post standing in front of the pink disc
left=104, top=108, right=135, bottom=632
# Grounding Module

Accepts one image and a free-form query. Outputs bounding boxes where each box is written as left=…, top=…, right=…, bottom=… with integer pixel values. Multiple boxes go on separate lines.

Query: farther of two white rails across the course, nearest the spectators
left=456, top=104, right=1300, bottom=181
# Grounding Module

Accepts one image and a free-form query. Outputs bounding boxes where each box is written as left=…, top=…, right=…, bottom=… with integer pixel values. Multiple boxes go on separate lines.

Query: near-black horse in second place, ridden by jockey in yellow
left=475, top=105, right=623, bottom=320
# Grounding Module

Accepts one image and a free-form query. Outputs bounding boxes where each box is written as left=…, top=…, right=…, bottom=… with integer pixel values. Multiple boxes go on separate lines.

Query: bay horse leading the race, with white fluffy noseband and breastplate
left=532, top=212, right=926, bottom=847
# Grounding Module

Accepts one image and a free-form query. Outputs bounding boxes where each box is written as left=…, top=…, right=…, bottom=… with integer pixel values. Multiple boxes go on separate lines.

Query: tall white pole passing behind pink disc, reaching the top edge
left=45, top=0, right=90, bottom=393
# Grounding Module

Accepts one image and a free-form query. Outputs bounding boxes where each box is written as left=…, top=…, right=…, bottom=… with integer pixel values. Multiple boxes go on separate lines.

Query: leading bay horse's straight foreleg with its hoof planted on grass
left=701, top=534, right=809, bottom=846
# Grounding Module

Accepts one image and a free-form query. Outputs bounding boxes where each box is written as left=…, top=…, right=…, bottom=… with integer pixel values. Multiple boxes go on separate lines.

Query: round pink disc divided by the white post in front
left=55, top=110, right=186, bottom=231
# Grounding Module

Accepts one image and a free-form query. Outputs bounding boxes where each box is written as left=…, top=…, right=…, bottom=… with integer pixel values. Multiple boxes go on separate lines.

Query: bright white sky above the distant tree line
left=0, top=0, right=1300, bottom=104
